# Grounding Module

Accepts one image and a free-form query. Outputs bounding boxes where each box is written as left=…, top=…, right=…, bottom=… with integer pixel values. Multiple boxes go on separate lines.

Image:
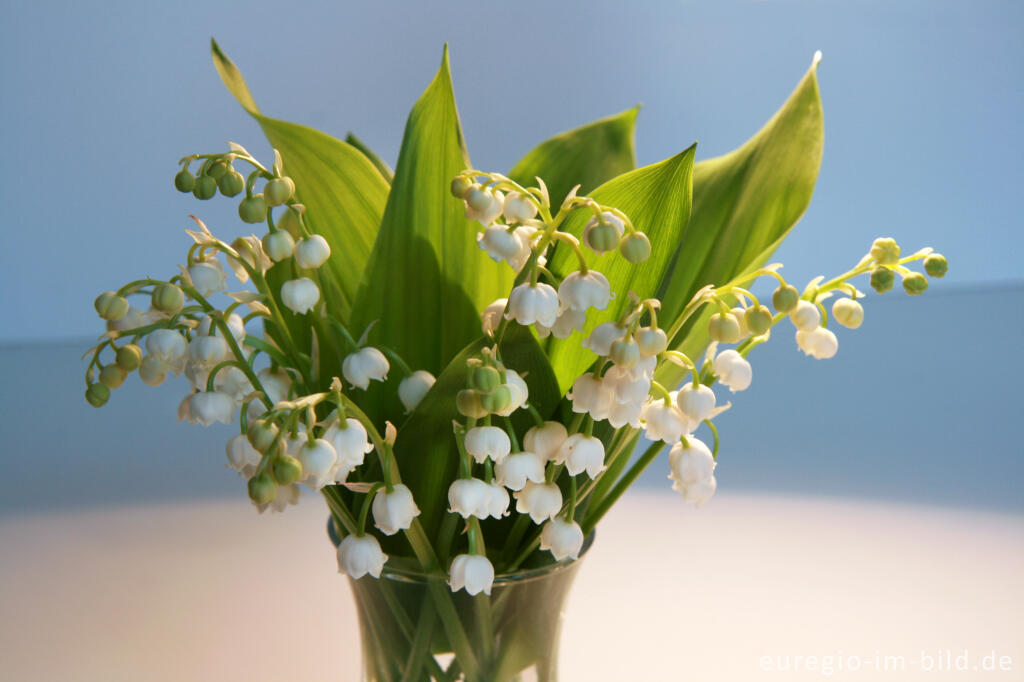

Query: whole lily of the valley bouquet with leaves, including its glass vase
left=86, top=44, right=946, bottom=680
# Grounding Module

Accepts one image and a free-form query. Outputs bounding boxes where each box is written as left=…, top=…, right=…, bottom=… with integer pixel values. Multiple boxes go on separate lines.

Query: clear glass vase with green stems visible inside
left=349, top=536, right=593, bottom=682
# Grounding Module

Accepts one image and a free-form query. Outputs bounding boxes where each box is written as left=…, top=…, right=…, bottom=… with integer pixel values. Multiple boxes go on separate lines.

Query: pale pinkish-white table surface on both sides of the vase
left=0, top=491, right=1024, bottom=682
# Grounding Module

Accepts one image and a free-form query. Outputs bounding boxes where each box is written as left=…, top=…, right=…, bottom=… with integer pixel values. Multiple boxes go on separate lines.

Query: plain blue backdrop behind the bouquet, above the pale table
left=0, top=0, right=1024, bottom=512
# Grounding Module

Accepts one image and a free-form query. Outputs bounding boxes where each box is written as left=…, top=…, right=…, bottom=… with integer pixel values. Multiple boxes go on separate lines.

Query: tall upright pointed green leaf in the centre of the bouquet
left=351, top=47, right=512, bottom=419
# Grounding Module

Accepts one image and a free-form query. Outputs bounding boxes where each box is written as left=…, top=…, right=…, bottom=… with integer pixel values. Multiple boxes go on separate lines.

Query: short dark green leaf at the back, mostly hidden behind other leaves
left=509, top=106, right=640, bottom=207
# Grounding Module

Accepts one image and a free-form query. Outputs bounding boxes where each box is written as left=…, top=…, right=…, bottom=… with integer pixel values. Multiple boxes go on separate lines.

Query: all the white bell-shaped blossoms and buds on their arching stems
left=86, top=145, right=946, bottom=595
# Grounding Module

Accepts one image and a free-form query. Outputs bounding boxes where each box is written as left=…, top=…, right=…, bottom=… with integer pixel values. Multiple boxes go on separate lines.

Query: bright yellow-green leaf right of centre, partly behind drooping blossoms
left=547, top=144, right=696, bottom=392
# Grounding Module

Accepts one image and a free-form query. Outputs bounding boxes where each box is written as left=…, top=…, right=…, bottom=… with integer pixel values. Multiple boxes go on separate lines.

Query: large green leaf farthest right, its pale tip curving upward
left=659, top=56, right=824, bottom=384
